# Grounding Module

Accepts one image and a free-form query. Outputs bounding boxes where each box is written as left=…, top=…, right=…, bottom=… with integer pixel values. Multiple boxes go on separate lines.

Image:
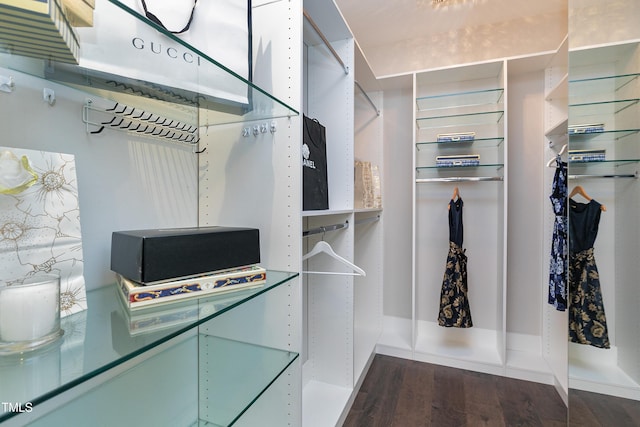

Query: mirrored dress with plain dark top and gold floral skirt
left=569, top=199, right=609, bottom=348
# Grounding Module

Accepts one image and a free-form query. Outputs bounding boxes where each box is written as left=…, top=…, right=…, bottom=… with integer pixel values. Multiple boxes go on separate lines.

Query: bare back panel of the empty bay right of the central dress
left=507, top=70, right=551, bottom=335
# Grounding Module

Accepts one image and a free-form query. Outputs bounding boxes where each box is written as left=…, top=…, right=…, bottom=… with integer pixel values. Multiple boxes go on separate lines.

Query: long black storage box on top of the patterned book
left=111, top=227, right=260, bottom=283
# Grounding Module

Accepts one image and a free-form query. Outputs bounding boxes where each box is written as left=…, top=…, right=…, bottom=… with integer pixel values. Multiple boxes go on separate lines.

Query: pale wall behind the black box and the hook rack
left=0, top=64, right=198, bottom=290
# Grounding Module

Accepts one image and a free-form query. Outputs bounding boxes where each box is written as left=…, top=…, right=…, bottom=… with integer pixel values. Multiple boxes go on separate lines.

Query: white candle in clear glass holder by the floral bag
left=0, top=275, right=64, bottom=354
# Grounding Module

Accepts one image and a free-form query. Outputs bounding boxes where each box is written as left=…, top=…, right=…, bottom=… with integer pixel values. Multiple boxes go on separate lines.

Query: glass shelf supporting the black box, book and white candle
left=0, top=271, right=298, bottom=422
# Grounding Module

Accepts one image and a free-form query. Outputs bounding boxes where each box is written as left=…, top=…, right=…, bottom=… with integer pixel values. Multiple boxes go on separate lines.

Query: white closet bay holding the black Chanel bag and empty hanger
left=302, top=6, right=355, bottom=426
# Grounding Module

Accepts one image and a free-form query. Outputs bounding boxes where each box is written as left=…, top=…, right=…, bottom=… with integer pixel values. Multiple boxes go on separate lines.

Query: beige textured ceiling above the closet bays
left=335, top=0, right=567, bottom=78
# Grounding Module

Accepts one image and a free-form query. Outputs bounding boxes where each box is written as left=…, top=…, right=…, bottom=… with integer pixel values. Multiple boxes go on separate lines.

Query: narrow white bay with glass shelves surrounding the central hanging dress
left=408, top=61, right=507, bottom=374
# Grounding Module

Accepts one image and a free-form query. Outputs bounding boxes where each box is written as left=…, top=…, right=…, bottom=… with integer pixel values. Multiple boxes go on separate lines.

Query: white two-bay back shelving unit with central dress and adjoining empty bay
left=377, top=48, right=567, bottom=392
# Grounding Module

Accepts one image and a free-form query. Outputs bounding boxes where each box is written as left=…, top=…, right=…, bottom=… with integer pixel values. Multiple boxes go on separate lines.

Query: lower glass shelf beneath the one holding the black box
left=199, top=335, right=298, bottom=426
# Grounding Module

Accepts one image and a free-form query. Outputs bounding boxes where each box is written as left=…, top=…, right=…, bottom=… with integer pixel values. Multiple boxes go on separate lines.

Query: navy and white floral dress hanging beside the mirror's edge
left=549, top=155, right=567, bottom=311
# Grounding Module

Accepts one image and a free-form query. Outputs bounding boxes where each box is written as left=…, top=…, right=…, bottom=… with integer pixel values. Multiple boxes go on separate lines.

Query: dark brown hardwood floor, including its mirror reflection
left=344, top=355, right=640, bottom=427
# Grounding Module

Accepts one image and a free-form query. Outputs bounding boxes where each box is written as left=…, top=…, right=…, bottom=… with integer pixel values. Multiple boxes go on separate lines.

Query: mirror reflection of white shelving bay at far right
left=569, top=40, right=640, bottom=400
